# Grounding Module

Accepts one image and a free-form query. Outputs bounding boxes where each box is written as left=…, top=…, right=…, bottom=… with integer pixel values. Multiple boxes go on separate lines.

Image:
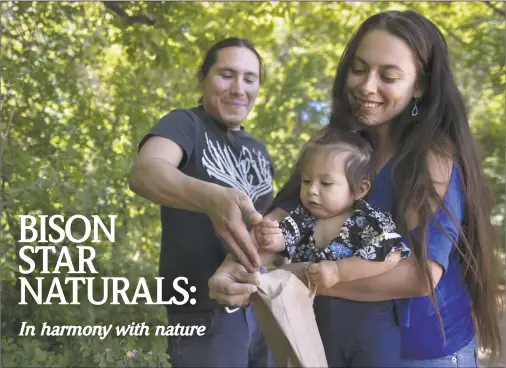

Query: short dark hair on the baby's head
left=296, top=126, right=376, bottom=194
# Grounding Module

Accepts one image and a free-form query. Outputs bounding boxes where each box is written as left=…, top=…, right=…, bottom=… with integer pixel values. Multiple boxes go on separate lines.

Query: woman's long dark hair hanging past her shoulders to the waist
left=273, top=11, right=501, bottom=358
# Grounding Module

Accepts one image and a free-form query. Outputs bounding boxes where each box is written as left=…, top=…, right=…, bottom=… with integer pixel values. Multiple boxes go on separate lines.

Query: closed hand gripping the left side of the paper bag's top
left=208, top=255, right=260, bottom=307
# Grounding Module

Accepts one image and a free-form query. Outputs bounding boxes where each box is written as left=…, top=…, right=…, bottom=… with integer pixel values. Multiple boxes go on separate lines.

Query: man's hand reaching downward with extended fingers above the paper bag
left=206, top=187, right=262, bottom=272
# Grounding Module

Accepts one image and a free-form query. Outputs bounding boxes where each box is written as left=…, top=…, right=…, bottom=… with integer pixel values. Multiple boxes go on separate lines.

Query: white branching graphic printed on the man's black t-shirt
left=202, top=133, right=272, bottom=202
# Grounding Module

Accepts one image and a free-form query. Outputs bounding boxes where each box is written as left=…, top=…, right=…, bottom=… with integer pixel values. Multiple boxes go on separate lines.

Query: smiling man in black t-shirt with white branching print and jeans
left=130, top=38, right=273, bottom=367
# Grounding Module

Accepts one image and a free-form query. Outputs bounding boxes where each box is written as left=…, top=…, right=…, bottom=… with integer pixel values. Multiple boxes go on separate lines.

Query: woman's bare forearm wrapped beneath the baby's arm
left=317, top=258, right=443, bottom=302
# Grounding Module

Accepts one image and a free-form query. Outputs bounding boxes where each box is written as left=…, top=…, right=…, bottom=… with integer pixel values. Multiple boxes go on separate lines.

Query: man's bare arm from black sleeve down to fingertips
left=129, top=136, right=262, bottom=271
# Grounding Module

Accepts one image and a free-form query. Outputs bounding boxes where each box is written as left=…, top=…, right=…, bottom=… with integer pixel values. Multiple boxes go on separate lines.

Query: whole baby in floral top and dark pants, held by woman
left=252, top=128, right=411, bottom=367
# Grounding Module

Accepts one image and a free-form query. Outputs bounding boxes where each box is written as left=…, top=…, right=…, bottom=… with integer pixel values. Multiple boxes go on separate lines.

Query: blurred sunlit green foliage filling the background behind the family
left=0, top=2, right=505, bottom=367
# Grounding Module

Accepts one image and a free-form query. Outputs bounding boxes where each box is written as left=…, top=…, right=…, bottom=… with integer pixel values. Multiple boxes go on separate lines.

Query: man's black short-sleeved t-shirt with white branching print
left=139, top=106, right=274, bottom=313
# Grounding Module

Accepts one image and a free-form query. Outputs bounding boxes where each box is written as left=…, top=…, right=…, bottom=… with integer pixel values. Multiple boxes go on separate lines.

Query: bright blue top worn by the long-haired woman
left=280, top=160, right=475, bottom=360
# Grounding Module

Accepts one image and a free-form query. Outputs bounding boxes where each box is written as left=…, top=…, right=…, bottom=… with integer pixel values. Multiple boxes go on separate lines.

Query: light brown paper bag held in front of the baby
left=251, top=269, right=328, bottom=367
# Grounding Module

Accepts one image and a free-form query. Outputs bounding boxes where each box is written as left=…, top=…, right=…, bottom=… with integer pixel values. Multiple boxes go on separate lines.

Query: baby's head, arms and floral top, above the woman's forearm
left=254, top=128, right=410, bottom=288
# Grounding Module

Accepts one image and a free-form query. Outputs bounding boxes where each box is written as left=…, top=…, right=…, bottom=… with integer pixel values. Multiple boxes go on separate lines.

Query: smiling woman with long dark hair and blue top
left=209, top=11, right=501, bottom=367
